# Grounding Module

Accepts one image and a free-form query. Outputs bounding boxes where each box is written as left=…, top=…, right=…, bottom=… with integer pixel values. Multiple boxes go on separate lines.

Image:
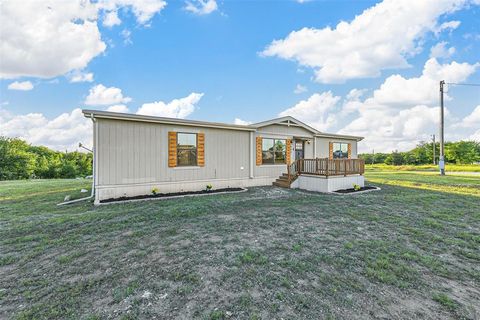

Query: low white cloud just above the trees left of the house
left=0, top=108, right=92, bottom=151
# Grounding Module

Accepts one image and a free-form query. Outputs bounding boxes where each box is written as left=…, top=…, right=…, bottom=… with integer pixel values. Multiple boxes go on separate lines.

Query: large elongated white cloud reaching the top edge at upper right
left=262, top=0, right=471, bottom=83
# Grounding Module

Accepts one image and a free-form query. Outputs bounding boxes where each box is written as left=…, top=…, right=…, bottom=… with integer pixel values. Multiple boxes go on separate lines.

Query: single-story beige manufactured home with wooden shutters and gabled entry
left=83, top=110, right=363, bottom=203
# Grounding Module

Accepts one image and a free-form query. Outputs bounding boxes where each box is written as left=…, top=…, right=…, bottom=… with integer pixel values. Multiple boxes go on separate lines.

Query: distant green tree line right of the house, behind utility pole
left=359, top=141, right=480, bottom=166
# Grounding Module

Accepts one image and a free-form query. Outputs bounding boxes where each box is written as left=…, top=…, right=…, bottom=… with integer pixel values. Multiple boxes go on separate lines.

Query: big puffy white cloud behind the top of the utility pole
left=339, top=59, right=479, bottom=151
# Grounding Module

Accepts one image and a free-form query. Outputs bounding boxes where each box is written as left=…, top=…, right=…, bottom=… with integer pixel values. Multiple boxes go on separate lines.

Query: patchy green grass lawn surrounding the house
left=0, top=175, right=480, bottom=319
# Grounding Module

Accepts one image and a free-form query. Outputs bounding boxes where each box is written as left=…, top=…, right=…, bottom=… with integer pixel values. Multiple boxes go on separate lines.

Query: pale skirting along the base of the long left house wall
left=95, top=176, right=275, bottom=204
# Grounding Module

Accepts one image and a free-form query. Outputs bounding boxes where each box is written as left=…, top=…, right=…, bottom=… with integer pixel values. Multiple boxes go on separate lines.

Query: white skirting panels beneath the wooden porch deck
left=290, top=174, right=365, bottom=192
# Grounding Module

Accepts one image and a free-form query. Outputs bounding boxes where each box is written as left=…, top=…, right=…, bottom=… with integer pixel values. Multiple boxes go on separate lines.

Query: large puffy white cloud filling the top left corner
left=0, top=0, right=106, bottom=78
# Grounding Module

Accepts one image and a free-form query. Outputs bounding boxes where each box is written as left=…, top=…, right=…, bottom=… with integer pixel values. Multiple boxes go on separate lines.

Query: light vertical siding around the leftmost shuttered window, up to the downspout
left=97, top=119, right=250, bottom=185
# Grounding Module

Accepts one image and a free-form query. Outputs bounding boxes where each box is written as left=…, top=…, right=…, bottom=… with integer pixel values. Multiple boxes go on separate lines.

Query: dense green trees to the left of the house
left=0, top=137, right=93, bottom=180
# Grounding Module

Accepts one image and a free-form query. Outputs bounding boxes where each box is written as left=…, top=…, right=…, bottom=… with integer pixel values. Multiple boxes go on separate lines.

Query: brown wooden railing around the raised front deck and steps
left=287, top=158, right=365, bottom=182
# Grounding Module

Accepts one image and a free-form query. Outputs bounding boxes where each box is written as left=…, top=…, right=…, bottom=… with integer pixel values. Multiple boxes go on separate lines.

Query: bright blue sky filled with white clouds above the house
left=0, top=0, right=480, bottom=152
